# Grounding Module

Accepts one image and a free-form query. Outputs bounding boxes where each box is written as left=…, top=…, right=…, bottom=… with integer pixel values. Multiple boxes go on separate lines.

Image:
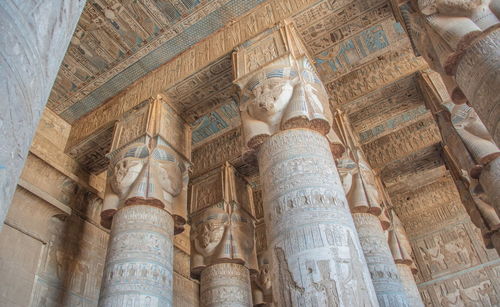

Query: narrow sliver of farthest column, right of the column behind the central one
left=388, top=211, right=424, bottom=307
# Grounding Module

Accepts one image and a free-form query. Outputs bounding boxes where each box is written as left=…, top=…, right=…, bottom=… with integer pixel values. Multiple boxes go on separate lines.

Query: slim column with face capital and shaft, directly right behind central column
left=338, top=150, right=409, bottom=306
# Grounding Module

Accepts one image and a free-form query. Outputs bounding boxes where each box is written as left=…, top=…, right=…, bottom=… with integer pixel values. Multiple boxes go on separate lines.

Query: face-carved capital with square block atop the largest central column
left=233, top=23, right=332, bottom=149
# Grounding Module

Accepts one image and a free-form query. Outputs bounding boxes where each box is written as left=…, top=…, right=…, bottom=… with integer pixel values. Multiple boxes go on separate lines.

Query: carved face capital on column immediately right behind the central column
left=337, top=149, right=382, bottom=215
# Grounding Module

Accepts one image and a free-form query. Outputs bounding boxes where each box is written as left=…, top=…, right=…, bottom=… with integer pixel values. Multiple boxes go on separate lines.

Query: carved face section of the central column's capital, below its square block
left=240, top=57, right=336, bottom=148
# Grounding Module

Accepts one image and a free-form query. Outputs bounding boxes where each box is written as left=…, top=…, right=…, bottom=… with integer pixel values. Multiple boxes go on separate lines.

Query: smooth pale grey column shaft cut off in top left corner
left=0, top=0, right=85, bottom=229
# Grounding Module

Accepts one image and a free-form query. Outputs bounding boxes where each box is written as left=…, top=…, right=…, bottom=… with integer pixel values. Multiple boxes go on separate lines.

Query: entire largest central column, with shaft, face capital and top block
left=233, top=23, right=378, bottom=307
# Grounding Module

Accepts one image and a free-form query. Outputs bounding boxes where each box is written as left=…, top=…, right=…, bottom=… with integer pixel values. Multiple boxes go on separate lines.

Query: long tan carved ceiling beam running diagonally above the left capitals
left=67, top=0, right=324, bottom=150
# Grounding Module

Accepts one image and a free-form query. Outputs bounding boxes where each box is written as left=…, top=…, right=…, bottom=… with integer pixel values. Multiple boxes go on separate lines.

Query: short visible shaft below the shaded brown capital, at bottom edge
left=200, top=263, right=252, bottom=307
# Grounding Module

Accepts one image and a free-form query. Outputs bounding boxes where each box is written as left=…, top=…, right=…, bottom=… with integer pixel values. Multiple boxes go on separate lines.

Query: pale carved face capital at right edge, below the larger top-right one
left=450, top=104, right=500, bottom=165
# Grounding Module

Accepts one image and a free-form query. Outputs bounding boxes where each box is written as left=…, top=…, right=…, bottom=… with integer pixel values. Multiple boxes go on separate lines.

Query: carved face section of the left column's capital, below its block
left=101, top=137, right=186, bottom=227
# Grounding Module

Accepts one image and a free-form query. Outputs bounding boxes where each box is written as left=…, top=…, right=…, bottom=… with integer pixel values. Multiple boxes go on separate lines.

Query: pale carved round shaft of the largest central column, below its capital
left=258, top=129, right=378, bottom=307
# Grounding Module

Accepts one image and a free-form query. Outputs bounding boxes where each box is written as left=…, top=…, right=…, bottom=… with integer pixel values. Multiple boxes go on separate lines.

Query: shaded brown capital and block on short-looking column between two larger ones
left=189, top=163, right=257, bottom=277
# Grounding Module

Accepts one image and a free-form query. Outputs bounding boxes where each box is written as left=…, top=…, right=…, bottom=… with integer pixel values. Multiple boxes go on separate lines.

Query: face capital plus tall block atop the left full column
left=101, top=97, right=189, bottom=230
